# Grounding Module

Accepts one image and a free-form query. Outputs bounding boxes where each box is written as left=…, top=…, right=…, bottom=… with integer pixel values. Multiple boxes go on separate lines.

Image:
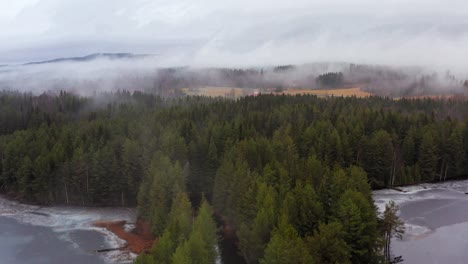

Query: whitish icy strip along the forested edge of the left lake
left=0, top=197, right=136, bottom=263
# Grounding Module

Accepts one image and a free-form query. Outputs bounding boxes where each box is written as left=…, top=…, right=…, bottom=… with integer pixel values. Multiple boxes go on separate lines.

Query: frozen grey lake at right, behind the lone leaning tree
left=374, top=180, right=468, bottom=264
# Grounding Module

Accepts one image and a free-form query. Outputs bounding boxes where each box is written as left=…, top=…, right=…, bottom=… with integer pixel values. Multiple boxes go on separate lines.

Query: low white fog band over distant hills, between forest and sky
left=0, top=56, right=468, bottom=97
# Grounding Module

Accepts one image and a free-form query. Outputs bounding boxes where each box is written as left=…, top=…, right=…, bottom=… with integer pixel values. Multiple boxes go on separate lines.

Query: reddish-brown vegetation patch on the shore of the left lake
left=94, top=219, right=155, bottom=254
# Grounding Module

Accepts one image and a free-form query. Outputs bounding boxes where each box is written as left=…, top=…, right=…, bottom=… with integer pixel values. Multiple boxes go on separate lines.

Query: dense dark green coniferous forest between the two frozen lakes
left=0, top=91, right=468, bottom=264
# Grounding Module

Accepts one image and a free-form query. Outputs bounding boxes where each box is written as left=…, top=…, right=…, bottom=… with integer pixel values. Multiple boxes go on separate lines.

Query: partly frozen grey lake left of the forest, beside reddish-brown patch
left=0, top=198, right=136, bottom=264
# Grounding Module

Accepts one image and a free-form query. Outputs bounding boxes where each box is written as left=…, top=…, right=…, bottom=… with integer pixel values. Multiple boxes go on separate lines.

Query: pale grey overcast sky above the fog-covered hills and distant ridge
left=0, top=0, right=468, bottom=68
